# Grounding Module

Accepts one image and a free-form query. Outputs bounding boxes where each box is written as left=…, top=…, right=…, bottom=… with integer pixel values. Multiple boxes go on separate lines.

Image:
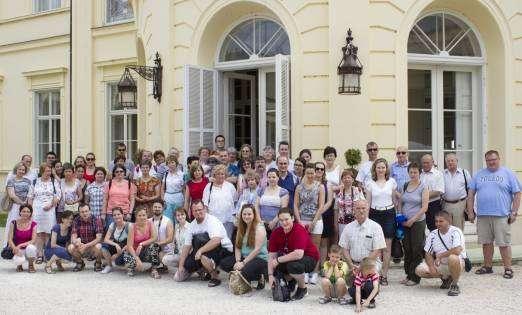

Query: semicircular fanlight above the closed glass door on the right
left=408, top=13, right=482, bottom=57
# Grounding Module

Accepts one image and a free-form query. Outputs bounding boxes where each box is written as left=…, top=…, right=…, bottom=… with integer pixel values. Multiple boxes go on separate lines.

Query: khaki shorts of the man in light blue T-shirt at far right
left=477, top=216, right=511, bottom=246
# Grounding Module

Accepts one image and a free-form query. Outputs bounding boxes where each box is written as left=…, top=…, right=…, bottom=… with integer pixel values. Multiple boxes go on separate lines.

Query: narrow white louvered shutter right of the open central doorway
left=275, top=55, right=290, bottom=145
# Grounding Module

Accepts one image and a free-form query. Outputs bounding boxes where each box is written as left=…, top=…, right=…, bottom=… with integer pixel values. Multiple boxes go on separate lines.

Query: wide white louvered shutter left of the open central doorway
left=183, top=65, right=218, bottom=156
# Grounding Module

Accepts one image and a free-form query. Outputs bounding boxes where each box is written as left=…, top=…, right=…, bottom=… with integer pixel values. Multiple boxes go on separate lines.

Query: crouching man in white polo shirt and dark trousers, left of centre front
left=174, top=200, right=233, bottom=287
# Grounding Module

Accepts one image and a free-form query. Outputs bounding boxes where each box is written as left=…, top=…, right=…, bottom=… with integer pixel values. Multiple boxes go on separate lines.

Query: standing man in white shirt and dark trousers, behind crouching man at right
left=420, top=154, right=444, bottom=231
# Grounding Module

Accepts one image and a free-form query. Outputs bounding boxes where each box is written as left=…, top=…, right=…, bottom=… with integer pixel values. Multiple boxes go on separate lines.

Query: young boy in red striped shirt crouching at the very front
left=348, top=257, right=379, bottom=313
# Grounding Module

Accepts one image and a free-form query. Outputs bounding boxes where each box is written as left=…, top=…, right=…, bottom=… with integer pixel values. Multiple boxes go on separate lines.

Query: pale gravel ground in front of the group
left=0, top=260, right=522, bottom=314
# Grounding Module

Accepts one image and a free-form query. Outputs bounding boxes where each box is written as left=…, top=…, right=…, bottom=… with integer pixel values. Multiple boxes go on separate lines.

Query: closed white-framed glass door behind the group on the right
left=408, top=66, right=482, bottom=170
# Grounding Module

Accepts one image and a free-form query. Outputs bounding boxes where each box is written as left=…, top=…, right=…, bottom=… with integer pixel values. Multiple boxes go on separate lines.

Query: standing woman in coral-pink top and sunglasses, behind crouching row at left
left=101, top=165, right=136, bottom=227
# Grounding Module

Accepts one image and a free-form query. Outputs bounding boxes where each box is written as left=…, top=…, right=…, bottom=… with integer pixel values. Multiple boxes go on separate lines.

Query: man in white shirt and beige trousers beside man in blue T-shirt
left=442, top=153, right=471, bottom=231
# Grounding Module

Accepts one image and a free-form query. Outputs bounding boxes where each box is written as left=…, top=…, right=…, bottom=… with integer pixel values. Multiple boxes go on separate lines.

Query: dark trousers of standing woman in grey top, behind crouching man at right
left=402, top=220, right=426, bottom=283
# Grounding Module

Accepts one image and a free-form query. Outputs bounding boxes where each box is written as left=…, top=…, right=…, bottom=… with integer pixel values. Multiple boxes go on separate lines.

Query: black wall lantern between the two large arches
left=337, top=29, right=362, bottom=94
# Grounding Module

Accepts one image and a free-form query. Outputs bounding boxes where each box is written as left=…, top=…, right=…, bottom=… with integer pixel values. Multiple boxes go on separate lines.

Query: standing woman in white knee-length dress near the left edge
left=32, top=163, right=62, bottom=264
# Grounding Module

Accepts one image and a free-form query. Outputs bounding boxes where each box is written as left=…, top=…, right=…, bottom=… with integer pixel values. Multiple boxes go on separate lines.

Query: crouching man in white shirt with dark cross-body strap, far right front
left=415, top=211, right=466, bottom=296
